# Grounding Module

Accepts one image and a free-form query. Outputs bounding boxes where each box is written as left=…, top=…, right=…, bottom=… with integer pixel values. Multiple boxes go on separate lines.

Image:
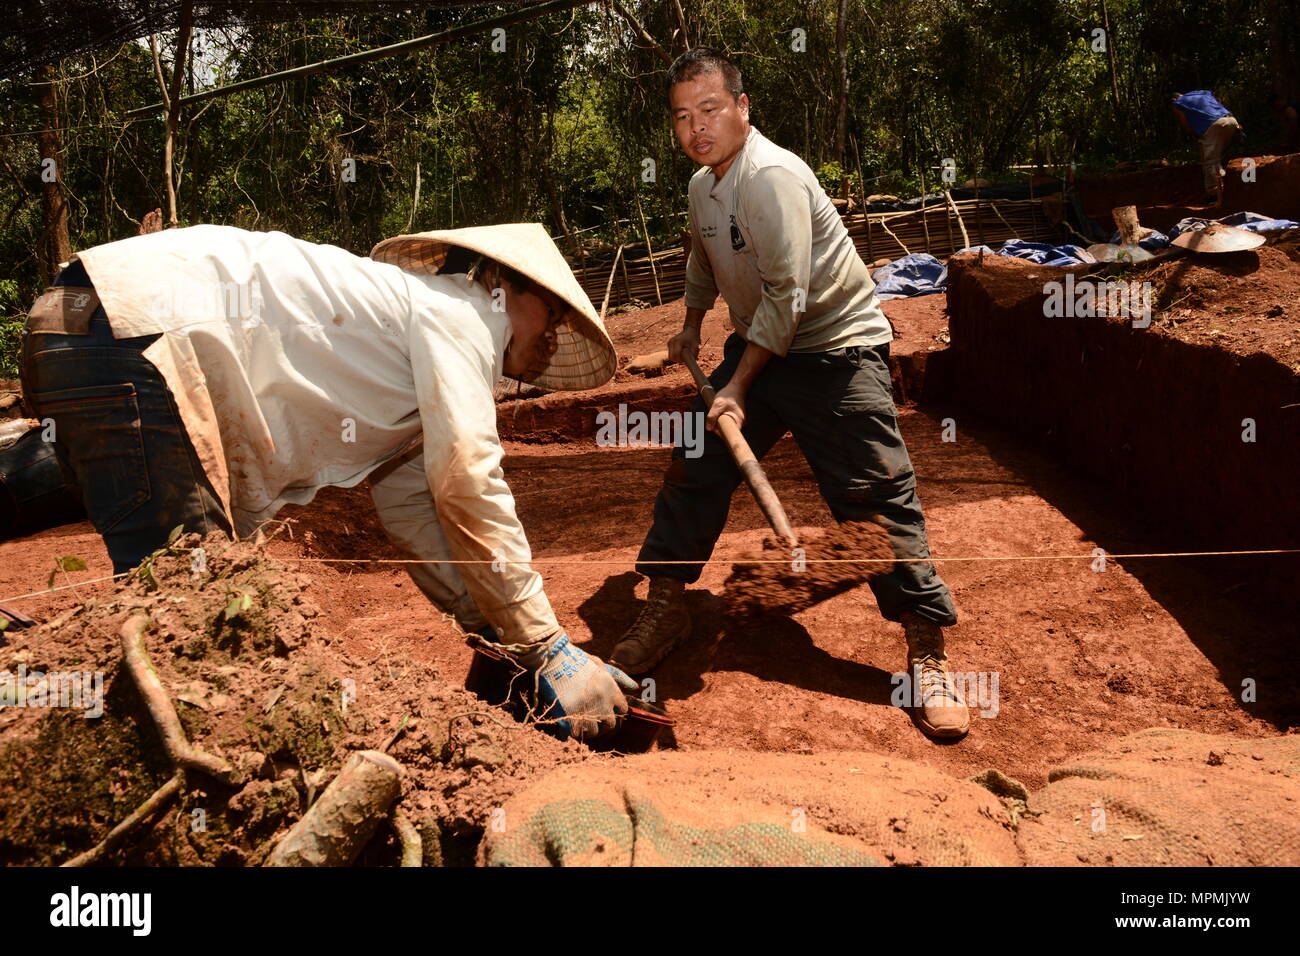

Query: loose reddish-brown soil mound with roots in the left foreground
left=0, top=535, right=590, bottom=865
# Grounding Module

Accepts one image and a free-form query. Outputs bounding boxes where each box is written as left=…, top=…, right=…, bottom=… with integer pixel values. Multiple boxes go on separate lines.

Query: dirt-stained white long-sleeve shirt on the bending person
left=74, top=225, right=559, bottom=643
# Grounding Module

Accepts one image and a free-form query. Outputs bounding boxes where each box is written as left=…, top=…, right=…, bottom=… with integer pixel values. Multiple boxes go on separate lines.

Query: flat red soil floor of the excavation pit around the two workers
left=0, top=297, right=1300, bottom=786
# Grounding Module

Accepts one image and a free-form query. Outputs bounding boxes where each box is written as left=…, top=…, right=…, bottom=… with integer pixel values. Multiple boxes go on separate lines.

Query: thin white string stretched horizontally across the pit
left=0, top=548, right=1300, bottom=604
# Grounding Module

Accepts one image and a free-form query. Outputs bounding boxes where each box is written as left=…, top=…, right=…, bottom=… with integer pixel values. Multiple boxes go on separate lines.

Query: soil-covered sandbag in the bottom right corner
left=1019, top=728, right=1300, bottom=866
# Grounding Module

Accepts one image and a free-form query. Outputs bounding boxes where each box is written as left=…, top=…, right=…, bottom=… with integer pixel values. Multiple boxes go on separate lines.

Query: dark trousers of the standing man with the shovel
left=637, top=333, right=957, bottom=627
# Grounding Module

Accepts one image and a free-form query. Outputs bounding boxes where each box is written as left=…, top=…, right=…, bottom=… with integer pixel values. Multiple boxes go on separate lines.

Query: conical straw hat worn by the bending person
left=371, top=222, right=618, bottom=390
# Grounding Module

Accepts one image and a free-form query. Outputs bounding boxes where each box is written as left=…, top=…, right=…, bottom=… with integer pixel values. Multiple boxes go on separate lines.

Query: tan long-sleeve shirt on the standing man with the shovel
left=686, top=126, right=893, bottom=355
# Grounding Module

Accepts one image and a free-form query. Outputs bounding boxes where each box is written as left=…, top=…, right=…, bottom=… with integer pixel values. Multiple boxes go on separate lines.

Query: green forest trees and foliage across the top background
left=0, top=0, right=1284, bottom=377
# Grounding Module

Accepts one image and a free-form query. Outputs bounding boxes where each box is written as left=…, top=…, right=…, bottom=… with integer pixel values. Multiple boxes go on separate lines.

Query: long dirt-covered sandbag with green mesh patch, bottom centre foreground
left=478, top=750, right=1021, bottom=866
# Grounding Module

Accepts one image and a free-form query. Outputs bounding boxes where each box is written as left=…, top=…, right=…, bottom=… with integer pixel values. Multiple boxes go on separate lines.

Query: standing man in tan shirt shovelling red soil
left=611, top=48, right=970, bottom=737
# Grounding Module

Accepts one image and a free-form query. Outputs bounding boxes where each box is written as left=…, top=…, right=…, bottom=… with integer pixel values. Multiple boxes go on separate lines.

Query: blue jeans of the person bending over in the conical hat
left=22, top=261, right=230, bottom=574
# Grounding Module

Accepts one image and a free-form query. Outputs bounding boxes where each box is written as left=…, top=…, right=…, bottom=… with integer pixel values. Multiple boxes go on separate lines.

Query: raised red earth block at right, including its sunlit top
left=949, top=246, right=1300, bottom=621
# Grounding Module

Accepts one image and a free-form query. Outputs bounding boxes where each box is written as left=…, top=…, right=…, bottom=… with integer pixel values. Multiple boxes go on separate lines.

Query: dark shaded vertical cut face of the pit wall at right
left=948, top=254, right=1300, bottom=616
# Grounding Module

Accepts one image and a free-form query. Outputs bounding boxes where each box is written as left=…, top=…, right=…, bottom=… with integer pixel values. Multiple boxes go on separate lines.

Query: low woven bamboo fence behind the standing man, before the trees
left=569, top=198, right=1060, bottom=308
